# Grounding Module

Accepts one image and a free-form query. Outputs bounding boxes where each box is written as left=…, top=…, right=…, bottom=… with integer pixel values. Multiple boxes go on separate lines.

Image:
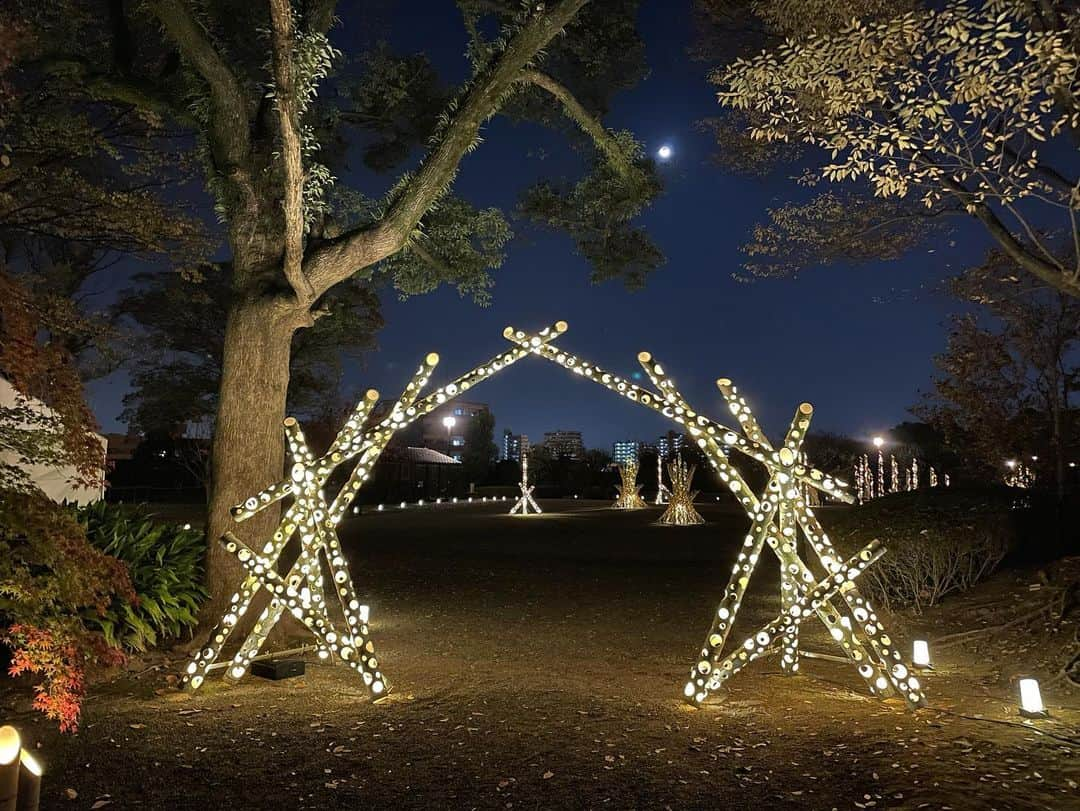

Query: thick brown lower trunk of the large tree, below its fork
left=201, top=297, right=297, bottom=630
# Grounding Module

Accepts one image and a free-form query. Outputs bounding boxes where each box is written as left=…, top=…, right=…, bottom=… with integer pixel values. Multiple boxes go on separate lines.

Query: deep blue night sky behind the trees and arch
left=91, top=0, right=986, bottom=450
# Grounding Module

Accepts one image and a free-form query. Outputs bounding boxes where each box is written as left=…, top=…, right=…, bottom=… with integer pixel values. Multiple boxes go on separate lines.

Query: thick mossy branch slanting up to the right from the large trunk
left=305, top=0, right=589, bottom=296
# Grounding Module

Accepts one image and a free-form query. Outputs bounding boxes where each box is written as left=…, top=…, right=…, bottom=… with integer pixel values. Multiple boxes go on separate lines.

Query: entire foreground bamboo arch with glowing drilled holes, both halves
left=190, top=321, right=924, bottom=706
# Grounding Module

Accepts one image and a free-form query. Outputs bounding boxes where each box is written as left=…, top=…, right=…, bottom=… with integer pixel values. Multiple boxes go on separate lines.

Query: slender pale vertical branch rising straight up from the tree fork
left=270, top=0, right=315, bottom=307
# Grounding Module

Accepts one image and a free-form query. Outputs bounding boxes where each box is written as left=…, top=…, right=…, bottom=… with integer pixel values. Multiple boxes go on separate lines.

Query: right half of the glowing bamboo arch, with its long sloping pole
left=504, top=328, right=926, bottom=706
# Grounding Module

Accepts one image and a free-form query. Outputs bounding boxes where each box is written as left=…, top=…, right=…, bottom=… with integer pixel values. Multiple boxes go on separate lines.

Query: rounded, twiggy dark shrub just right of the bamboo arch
left=826, top=488, right=1025, bottom=612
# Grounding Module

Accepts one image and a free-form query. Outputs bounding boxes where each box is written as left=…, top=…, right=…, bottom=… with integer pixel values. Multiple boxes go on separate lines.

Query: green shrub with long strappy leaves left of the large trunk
left=78, top=501, right=206, bottom=651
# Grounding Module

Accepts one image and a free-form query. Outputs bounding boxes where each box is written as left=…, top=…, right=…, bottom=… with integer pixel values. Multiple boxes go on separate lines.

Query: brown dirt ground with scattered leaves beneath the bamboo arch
left=0, top=501, right=1080, bottom=809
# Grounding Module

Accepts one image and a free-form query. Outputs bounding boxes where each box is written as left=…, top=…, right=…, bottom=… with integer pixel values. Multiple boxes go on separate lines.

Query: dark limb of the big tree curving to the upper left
left=149, top=0, right=251, bottom=174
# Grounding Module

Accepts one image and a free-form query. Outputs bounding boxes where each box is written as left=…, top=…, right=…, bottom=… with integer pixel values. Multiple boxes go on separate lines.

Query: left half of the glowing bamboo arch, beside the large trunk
left=181, top=322, right=566, bottom=699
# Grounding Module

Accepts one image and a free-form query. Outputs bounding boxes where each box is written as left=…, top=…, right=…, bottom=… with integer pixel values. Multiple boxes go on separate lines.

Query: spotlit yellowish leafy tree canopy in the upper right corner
left=703, top=0, right=1080, bottom=295
